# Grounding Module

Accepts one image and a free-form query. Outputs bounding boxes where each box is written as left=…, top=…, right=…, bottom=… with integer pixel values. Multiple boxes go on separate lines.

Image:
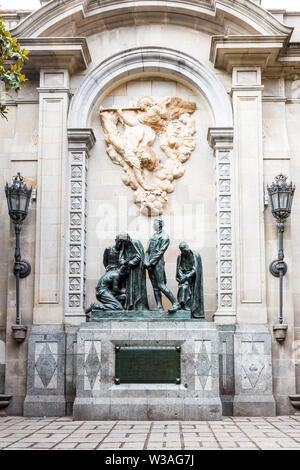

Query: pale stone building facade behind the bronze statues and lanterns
left=0, top=0, right=300, bottom=419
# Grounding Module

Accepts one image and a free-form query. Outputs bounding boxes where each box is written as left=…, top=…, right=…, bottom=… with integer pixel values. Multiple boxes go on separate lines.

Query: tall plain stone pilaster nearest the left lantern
left=33, top=69, right=69, bottom=324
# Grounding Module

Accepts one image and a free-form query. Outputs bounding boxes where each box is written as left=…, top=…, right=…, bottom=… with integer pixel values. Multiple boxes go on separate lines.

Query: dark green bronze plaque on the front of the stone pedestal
left=115, top=346, right=181, bottom=384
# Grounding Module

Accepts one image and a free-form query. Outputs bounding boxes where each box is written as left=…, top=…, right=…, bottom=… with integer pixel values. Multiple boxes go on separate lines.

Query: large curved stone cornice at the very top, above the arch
left=12, top=0, right=293, bottom=37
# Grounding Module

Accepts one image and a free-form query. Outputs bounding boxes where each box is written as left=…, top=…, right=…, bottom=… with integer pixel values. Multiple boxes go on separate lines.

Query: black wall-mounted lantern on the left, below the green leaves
left=5, top=173, right=32, bottom=342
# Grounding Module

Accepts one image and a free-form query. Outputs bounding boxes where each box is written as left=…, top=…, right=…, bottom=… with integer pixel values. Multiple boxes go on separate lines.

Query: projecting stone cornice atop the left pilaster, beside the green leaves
left=19, top=38, right=91, bottom=74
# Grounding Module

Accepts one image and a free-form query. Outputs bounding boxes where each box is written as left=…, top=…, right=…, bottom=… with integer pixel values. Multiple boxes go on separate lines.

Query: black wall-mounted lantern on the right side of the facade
left=267, top=174, right=295, bottom=342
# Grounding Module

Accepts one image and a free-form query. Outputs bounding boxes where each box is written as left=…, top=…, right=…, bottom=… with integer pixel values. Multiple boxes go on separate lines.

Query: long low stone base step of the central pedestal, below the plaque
left=73, top=398, right=222, bottom=421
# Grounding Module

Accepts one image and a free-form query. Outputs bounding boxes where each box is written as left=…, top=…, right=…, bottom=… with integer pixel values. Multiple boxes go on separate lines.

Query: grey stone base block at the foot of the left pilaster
left=24, top=395, right=66, bottom=417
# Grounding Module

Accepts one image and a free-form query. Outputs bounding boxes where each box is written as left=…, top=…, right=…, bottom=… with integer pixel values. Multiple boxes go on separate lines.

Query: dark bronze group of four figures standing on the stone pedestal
left=86, top=219, right=204, bottom=318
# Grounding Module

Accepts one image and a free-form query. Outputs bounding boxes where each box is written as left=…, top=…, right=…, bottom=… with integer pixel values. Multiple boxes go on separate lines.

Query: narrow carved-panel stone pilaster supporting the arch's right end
left=208, top=128, right=236, bottom=324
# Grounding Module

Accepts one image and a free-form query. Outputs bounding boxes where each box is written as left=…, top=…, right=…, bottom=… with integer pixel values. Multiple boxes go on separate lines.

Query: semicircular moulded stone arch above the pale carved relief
left=68, top=47, right=232, bottom=128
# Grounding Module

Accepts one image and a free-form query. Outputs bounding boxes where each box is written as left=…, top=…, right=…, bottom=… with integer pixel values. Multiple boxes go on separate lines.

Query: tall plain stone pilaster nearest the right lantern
left=232, top=67, right=267, bottom=323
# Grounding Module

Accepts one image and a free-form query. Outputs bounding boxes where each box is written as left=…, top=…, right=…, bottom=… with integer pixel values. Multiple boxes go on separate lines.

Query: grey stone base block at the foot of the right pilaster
left=233, top=395, right=276, bottom=416
